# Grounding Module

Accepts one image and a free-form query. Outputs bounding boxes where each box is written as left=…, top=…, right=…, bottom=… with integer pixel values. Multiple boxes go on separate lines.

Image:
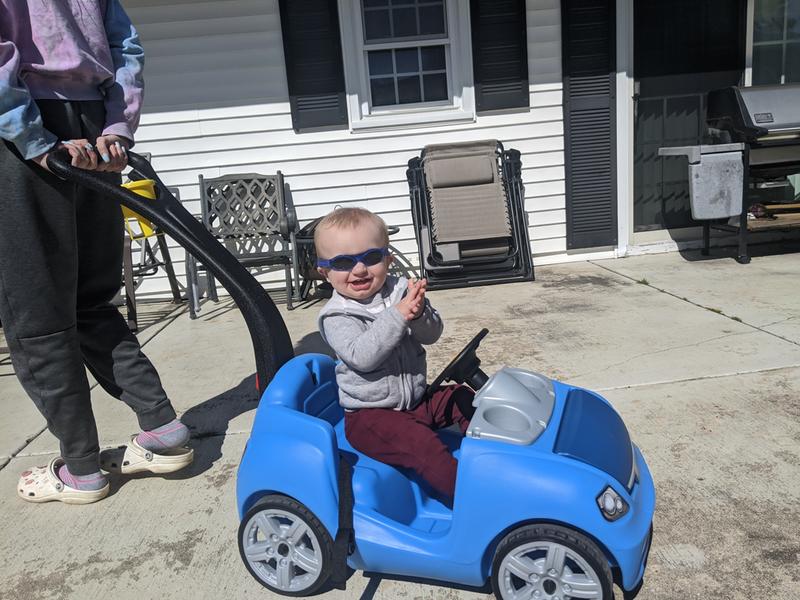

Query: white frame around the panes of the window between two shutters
left=339, top=0, right=475, bottom=131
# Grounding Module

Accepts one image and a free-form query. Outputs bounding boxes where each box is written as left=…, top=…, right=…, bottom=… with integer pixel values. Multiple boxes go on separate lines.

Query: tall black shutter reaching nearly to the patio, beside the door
left=561, top=0, right=617, bottom=249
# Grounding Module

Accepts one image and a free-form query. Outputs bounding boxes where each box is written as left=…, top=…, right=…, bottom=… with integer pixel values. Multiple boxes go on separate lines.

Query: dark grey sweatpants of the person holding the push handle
left=0, top=100, right=175, bottom=475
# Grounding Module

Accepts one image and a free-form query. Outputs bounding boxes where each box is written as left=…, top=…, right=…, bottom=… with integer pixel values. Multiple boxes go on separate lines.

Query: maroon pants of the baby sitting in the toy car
left=344, top=385, right=475, bottom=502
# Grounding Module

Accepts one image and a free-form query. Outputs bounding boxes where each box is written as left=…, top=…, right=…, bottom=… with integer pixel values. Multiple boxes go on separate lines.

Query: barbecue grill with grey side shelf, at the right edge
left=659, top=84, right=800, bottom=263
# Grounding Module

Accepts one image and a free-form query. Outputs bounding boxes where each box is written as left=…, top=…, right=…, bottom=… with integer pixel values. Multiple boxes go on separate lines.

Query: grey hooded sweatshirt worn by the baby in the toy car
left=319, top=276, right=442, bottom=410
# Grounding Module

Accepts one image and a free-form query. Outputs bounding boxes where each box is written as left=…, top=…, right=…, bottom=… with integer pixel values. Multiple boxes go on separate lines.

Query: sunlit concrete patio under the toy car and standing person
left=0, top=248, right=800, bottom=600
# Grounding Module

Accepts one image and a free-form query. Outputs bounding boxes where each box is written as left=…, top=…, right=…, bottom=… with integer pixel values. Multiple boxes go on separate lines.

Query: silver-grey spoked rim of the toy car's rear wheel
left=242, top=508, right=322, bottom=592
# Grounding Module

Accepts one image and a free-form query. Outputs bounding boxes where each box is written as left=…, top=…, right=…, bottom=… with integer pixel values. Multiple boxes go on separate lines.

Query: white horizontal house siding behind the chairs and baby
left=123, top=0, right=567, bottom=296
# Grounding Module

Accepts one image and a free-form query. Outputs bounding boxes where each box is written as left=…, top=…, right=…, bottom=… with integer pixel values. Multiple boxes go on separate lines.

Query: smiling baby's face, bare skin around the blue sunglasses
left=317, top=222, right=392, bottom=300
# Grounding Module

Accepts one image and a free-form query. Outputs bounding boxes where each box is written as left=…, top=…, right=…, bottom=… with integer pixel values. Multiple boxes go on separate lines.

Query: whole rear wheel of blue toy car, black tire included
left=238, top=495, right=333, bottom=596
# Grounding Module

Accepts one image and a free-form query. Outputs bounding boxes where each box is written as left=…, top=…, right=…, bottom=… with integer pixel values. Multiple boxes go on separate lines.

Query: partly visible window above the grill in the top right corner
left=752, top=0, right=800, bottom=85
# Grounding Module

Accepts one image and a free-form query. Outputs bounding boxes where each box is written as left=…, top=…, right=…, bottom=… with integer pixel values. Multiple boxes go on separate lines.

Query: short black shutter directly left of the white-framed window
left=280, top=0, right=347, bottom=131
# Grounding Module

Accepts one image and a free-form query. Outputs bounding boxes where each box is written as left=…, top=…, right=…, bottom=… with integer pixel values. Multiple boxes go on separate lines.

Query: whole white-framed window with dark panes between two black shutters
left=339, top=0, right=475, bottom=129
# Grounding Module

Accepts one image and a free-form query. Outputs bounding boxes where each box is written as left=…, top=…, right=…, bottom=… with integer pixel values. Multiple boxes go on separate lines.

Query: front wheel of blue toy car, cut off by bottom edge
left=492, top=525, right=614, bottom=600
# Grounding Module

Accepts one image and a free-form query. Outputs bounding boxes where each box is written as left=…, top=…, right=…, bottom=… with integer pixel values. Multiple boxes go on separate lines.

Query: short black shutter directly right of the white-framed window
left=472, top=0, right=529, bottom=113
